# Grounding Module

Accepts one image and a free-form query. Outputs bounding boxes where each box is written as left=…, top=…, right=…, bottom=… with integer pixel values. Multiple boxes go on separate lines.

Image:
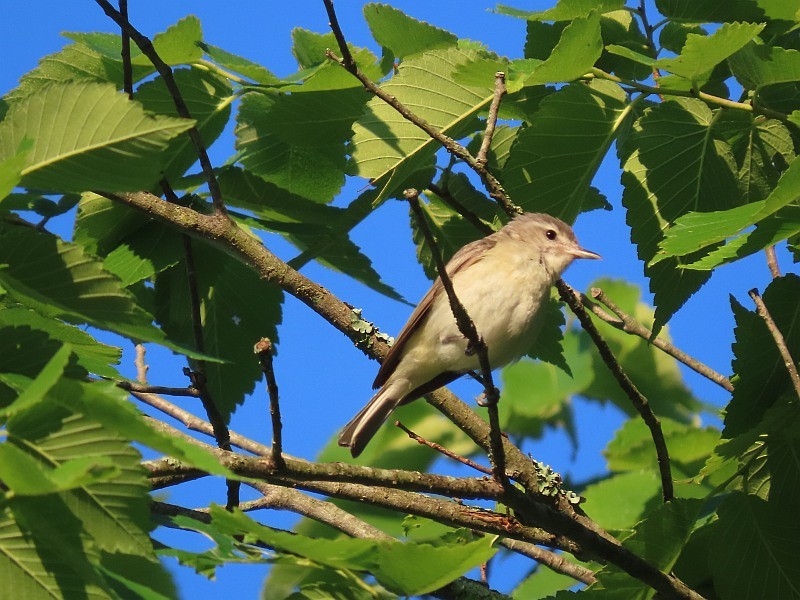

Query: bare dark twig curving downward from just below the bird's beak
left=556, top=279, right=674, bottom=502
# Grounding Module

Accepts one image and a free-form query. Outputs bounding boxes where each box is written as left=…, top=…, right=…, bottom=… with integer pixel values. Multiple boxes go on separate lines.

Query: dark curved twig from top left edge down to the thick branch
left=95, top=0, right=227, bottom=215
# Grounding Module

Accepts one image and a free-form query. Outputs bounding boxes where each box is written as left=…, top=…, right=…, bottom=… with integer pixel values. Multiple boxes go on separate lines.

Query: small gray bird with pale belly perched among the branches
left=339, top=213, right=600, bottom=457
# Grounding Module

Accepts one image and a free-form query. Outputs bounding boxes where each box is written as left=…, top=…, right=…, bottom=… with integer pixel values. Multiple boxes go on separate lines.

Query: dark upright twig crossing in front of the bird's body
left=403, top=188, right=508, bottom=486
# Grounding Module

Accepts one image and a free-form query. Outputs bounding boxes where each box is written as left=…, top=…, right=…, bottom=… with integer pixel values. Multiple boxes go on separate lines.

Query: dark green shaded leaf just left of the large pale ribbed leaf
left=236, top=80, right=367, bottom=203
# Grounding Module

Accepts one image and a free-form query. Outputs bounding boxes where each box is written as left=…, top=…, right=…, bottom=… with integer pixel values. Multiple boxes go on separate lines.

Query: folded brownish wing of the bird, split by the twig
left=372, top=235, right=497, bottom=388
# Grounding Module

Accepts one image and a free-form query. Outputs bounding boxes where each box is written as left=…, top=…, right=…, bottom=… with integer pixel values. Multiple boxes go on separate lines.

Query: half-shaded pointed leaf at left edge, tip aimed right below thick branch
left=0, top=225, right=198, bottom=356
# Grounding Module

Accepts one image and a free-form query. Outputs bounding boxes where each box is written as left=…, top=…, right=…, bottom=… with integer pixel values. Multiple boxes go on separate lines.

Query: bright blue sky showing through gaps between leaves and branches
left=0, top=0, right=796, bottom=598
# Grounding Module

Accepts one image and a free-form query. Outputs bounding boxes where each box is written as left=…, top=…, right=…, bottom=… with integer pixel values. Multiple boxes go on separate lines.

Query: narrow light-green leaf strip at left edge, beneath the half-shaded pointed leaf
left=0, top=307, right=122, bottom=378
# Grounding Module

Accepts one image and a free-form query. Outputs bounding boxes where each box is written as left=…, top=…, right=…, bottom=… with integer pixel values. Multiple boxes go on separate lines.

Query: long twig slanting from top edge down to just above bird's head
left=323, top=0, right=522, bottom=217
